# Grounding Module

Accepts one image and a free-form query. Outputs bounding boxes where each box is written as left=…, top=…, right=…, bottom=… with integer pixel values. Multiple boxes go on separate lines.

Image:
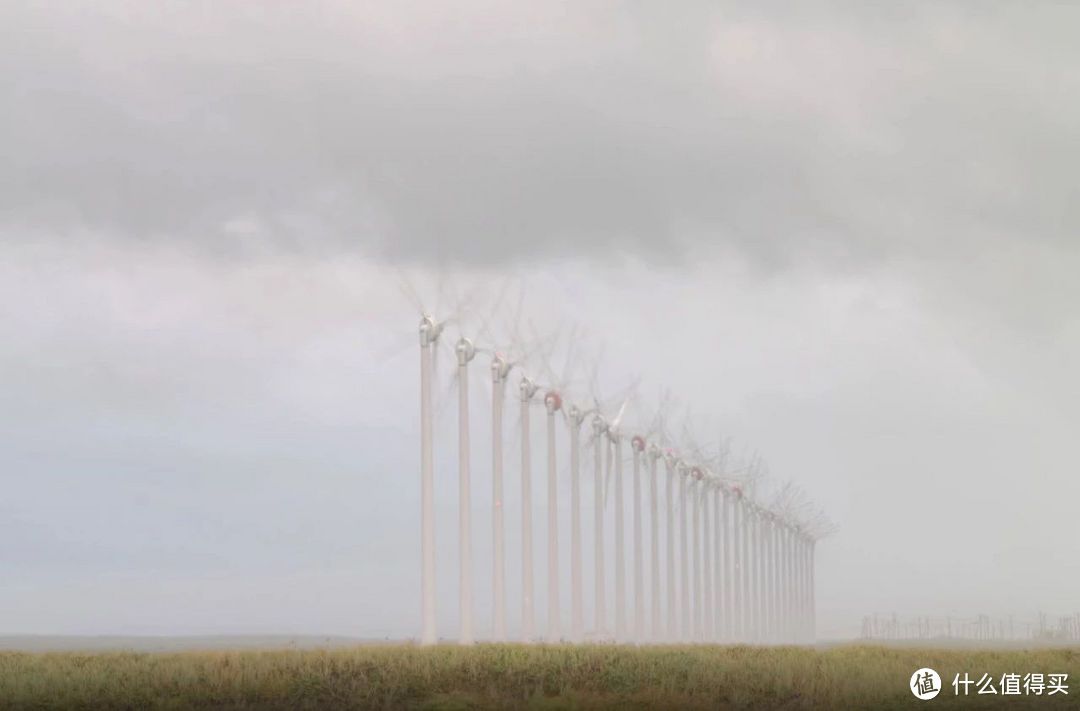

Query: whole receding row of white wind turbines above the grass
left=419, top=304, right=829, bottom=645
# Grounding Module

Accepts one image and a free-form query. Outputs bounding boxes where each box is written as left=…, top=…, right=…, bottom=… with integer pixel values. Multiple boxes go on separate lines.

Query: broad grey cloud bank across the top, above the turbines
left=0, top=2, right=1080, bottom=264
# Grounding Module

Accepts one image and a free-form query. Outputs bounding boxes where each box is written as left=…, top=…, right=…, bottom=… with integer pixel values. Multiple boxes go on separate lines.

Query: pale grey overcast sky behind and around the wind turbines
left=0, top=0, right=1080, bottom=636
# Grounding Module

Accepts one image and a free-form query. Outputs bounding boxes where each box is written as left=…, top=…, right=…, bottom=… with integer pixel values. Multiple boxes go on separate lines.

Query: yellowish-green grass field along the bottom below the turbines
left=0, top=645, right=1080, bottom=709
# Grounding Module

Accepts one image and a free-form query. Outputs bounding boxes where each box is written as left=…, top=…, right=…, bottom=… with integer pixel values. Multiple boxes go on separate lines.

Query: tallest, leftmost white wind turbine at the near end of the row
left=420, top=313, right=446, bottom=645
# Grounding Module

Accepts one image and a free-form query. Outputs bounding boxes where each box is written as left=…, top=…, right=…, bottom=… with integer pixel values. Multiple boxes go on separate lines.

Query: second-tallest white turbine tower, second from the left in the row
left=455, top=337, right=476, bottom=644
